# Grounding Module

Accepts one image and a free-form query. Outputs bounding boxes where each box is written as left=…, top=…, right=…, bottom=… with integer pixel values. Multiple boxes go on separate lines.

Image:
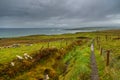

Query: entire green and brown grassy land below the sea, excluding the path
left=0, top=30, right=120, bottom=80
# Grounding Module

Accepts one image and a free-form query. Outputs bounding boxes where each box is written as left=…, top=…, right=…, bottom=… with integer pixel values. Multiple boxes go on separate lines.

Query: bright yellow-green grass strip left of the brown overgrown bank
left=0, top=40, right=71, bottom=64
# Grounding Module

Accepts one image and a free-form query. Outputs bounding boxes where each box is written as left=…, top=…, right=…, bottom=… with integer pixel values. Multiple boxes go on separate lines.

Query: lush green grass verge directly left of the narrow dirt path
left=59, top=43, right=91, bottom=80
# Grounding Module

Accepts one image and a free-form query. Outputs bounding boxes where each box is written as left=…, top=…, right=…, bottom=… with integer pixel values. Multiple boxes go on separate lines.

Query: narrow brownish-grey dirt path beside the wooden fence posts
left=90, top=43, right=100, bottom=80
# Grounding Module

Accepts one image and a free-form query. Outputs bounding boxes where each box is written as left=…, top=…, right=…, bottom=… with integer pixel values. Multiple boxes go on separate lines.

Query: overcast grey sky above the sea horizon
left=0, top=0, right=120, bottom=28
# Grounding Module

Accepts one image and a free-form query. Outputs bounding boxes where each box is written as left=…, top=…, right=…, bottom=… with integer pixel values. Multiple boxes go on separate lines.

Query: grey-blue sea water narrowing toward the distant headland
left=0, top=28, right=92, bottom=38
